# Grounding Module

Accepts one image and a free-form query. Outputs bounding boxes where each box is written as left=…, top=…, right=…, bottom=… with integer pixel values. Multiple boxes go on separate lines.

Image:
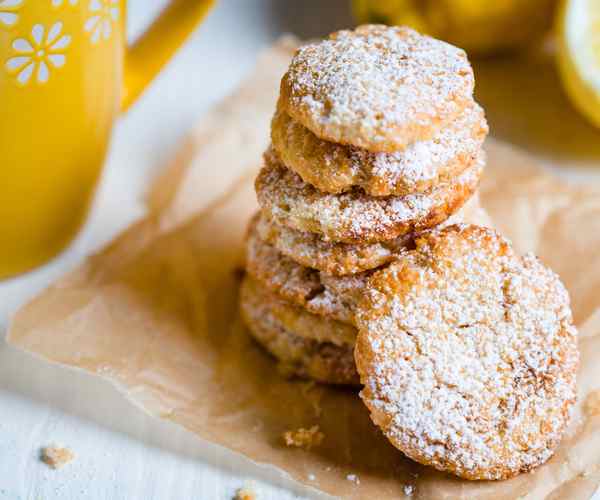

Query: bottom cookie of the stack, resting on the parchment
left=240, top=279, right=358, bottom=385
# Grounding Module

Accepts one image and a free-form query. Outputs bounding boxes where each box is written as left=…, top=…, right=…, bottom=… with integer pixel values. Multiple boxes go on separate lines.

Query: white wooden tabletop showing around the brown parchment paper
left=0, top=0, right=596, bottom=500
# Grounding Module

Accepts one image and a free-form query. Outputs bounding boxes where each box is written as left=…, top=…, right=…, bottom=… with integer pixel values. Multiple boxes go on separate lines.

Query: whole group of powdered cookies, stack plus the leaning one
left=241, top=26, right=578, bottom=479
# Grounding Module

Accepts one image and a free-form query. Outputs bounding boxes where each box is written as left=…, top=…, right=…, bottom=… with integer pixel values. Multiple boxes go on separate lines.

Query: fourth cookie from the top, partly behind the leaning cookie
left=256, top=193, right=491, bottom=276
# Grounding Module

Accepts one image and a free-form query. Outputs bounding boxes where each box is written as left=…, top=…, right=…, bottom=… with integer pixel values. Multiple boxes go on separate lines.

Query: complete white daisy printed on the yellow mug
left=6, top=22, right=71, bottom=85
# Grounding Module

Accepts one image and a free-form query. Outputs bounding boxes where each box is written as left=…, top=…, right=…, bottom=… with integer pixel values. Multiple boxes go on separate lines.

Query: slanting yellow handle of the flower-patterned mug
left=121, top=0, right=215, bottom=110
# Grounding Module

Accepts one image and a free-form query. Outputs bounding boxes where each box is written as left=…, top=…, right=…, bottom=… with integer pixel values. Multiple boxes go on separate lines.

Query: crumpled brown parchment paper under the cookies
left=9, top=40, right=600, bottom=499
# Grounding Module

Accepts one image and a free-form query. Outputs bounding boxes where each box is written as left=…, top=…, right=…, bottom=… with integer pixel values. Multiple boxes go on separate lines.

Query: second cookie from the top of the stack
left=271, top=104, right=488, bottom=196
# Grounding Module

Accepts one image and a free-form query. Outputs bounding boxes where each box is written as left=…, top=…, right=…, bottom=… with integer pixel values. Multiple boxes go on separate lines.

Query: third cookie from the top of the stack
left=255, top=150, right=485, bottom=243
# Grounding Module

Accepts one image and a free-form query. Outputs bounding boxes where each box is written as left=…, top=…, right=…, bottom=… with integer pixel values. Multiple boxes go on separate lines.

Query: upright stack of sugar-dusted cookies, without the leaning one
left=241, top=26, right=488, bottom=384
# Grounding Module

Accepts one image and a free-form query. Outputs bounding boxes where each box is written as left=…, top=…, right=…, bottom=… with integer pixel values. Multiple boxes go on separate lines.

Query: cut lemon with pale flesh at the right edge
left=557, top=0, right=600, bottom=127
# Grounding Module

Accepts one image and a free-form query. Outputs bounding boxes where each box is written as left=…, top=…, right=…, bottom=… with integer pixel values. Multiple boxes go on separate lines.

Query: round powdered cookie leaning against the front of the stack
left=355, top=225, right=578, bottom=479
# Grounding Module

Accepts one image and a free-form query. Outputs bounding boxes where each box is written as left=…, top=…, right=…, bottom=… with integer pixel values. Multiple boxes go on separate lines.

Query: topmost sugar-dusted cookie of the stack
left=280, top=25, right=474, bottom=152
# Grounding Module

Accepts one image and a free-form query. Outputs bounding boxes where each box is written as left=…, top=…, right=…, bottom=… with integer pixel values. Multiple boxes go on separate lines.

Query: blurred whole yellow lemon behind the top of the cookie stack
left=353, top=0, right=556, bottom=55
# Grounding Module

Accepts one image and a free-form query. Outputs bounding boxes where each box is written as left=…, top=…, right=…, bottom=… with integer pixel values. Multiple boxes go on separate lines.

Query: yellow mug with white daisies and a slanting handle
left=0, top=0, right=213, bottom=279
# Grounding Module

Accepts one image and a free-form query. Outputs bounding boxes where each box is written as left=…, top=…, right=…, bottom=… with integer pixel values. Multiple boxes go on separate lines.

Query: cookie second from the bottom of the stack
left=246, top=217, right=369, bottom=323
